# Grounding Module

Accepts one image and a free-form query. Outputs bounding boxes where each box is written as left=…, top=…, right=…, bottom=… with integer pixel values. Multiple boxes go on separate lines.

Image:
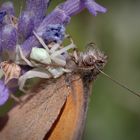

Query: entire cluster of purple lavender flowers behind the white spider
left=0, top=0, right=106, bottom=105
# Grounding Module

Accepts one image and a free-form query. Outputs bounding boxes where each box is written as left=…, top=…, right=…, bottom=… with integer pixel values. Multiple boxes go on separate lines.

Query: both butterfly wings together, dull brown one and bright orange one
left=0, top=75, right=94, bottom=140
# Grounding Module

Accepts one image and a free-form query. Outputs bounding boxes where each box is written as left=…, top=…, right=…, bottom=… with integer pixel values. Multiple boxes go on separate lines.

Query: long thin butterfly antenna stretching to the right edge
left=96, top=67, right=140, bottom=97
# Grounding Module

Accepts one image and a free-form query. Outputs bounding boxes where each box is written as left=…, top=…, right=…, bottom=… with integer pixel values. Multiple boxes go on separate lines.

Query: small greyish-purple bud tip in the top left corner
left=1, top=2, right=15, bottom=15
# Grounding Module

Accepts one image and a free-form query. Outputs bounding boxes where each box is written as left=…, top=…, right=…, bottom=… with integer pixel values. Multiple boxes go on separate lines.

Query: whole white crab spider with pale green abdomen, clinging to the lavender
left=18, top=32, right=75, bottom=92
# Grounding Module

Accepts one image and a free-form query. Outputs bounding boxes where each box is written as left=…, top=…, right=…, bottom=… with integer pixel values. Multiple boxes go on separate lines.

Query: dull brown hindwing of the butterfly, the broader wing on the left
left=0, top=77, right=69, bottom=140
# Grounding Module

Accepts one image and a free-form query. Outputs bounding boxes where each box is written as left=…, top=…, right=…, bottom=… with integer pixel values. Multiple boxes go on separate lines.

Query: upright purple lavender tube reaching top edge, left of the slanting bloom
left=18, top=0, right=50, bottom=42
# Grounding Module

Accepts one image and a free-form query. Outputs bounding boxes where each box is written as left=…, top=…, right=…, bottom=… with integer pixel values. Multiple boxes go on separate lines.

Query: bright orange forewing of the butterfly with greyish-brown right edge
left=45, top=75, right=92, bottom=140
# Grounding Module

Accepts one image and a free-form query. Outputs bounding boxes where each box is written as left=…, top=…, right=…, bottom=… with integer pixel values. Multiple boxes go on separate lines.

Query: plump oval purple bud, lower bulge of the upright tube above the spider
left=18, top=11, right=34, bottom=40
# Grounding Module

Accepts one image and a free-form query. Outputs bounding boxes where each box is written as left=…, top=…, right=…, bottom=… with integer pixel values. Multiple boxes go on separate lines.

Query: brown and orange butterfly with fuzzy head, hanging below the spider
left=0, top=45, right=106, bottom=140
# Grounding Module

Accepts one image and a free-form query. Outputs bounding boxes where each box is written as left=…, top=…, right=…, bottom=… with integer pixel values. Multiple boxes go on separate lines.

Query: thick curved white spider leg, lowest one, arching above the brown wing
left=18, top=69, right=52, bottom=93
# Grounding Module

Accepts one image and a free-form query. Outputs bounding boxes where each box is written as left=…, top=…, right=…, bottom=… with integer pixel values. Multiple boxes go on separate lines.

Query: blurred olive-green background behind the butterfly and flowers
left=0, top=0, right=140, bottom=140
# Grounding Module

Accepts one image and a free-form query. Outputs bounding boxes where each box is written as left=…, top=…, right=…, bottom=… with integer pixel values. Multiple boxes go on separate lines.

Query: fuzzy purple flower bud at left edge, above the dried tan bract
left=0, top=24, right=17, bottom=59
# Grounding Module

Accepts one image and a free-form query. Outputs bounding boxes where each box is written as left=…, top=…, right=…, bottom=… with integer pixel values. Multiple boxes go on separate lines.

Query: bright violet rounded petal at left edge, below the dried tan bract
left=0, top=80, right=9, bottom=106
